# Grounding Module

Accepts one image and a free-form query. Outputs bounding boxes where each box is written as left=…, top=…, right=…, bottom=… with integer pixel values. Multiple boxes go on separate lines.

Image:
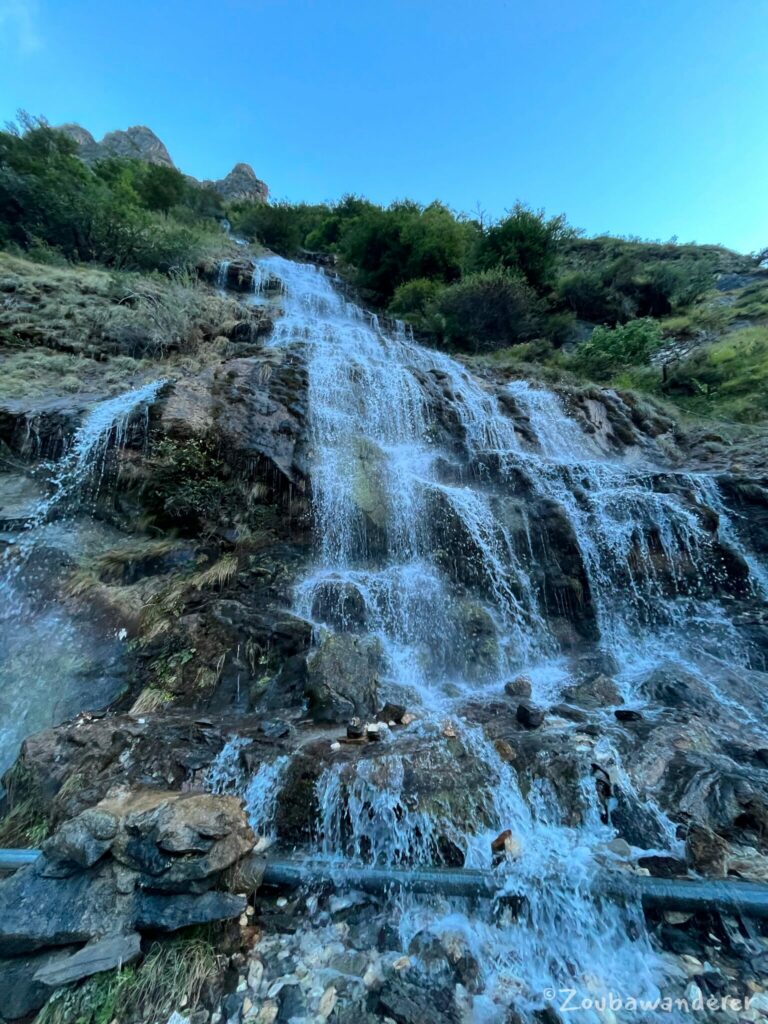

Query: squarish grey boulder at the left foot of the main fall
left=305, top=633, right=383, bottom=722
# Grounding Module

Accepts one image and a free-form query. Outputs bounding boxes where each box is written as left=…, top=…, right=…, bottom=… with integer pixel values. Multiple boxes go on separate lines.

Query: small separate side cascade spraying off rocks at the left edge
left=0, top=380, right=165, bottom=768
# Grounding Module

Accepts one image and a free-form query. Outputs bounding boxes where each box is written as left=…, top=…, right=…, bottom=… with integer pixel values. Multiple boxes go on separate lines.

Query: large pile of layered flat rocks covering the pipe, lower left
left=0, top=790, right=255, bottom=954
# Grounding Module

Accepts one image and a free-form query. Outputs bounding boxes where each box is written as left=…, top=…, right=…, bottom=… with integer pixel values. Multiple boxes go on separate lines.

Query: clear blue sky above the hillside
left=0, top=0, right=768, bottom=251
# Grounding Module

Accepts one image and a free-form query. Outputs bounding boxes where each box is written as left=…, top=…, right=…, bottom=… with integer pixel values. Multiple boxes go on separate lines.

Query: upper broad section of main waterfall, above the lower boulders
left=255, top=257, right=766, bottom=701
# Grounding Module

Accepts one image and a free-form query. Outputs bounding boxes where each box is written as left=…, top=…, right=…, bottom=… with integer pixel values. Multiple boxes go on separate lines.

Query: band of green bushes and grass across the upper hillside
left=0, top=118, right=768, bottom=422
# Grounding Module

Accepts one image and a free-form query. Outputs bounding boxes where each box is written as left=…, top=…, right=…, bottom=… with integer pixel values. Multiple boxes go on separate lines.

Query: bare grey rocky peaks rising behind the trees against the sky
left=57, top=124, right=269, bottom=203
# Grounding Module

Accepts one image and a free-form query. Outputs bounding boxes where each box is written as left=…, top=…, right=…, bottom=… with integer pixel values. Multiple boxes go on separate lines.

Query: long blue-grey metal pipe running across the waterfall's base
left=7, top=849, right=768, bottom=919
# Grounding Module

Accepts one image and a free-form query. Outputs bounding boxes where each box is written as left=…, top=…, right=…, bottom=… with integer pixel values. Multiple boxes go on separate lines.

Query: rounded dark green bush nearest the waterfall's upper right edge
left=437, top=269, right=541, bottom=352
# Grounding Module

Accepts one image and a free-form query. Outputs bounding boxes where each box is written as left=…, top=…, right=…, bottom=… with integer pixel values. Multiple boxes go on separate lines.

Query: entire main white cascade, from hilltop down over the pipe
left=241, top=257, right=764, bottom=1021
